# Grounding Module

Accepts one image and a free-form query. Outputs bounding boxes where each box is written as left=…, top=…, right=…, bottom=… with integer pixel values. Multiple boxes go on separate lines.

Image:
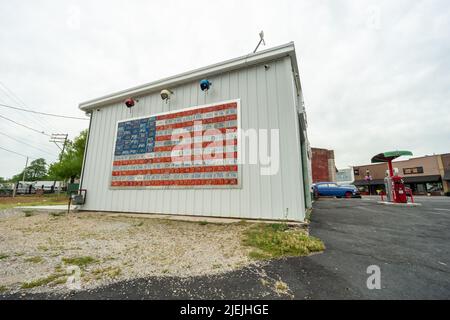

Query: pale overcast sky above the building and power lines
left=0, top=0, right=450, bottom=177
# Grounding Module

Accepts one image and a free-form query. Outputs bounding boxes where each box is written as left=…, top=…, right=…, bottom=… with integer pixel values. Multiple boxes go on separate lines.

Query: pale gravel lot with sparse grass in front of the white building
left=0, top=209, right=254, bottom=293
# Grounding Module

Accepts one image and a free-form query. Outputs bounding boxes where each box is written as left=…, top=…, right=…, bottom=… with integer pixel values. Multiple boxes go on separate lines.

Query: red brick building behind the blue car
left=311, top=148, right=336, bottom=183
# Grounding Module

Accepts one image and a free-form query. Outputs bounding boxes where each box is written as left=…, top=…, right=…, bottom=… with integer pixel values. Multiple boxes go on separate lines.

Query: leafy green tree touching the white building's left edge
left=48, top=130, right=87, bottom=183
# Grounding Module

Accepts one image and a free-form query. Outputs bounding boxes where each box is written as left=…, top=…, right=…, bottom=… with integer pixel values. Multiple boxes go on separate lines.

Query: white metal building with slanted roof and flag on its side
left=79, top=43, right=311, bottom=221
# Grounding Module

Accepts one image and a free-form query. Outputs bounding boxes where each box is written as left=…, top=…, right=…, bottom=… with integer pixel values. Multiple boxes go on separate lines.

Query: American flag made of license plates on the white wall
left=111, top=100, right=240, bottom=189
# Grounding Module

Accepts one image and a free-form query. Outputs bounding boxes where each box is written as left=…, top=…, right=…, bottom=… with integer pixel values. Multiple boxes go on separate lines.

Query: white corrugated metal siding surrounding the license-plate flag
left=83, top=57, right=305, bottom=221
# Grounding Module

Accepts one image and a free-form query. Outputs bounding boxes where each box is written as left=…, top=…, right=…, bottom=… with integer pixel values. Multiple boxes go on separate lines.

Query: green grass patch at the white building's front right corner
left=243, top=223, right=325, bottom=260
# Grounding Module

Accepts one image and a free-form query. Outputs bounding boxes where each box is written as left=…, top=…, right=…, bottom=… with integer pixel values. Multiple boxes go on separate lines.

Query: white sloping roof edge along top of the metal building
left=78, top=42, right=299, bottom=112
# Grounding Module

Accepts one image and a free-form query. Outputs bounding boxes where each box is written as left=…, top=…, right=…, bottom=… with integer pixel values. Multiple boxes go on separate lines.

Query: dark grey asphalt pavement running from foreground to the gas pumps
left=2, top=198, right=450, bottom=299
